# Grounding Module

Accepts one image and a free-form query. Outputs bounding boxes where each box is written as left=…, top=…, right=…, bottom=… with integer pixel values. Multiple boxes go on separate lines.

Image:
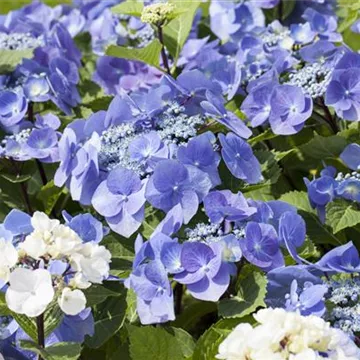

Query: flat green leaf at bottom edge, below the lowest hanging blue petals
left=129, top=327, right=184, bottom=360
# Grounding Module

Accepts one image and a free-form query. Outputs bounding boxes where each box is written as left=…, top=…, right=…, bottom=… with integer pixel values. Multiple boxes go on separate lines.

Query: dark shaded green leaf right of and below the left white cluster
left=85, top=287, right=127, bottom=348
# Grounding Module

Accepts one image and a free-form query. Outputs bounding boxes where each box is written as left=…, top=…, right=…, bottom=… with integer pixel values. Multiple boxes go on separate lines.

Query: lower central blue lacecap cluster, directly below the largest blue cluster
left=127, top=191, right=305, bottom=324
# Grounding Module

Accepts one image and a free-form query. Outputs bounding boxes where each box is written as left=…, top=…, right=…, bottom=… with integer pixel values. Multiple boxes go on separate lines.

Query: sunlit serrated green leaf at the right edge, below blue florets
left=326, top=199, right=360, bottom=234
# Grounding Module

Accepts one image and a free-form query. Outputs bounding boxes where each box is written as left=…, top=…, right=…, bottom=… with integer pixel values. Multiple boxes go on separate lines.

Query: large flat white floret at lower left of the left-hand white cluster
left=5, top=268, right=54, bottom=317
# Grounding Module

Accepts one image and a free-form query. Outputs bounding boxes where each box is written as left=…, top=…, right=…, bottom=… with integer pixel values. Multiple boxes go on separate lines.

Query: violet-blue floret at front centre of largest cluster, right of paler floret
left=145, top=160, right=212, bottom=224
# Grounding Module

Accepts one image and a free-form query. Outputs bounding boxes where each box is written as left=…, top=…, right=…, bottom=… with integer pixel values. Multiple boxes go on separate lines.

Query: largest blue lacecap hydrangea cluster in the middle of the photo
left=55, top=71, right=262, bottom=236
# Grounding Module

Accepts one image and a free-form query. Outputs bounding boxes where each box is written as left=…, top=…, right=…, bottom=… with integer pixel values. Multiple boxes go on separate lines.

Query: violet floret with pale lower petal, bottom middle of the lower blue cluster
left=174, top=242, right=230, bottom=301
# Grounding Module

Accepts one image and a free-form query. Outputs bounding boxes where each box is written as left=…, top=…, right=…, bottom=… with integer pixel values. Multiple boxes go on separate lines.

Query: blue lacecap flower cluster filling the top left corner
left=0, top=2, right=81, bottom=123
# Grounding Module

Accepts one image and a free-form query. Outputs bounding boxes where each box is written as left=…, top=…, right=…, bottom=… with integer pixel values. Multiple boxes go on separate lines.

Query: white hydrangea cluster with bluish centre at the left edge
left=0, top=212, right=111, bottom=317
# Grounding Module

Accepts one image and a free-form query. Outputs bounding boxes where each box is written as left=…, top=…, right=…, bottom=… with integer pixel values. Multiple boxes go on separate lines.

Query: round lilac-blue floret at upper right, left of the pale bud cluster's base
left=269, top=85, right=313, bottom=135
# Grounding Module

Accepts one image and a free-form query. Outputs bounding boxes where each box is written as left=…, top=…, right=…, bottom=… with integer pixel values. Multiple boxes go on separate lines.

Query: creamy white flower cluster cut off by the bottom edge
left=216, top=308, right=360, bottom=360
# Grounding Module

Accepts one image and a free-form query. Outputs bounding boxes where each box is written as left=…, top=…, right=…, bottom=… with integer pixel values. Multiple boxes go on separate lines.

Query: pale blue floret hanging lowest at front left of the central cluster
left=92, top=167, right=146, bottom=237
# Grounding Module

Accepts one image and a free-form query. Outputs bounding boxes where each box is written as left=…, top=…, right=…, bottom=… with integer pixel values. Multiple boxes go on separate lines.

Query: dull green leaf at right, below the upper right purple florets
left=299, top=135, right=347, bottom=160
